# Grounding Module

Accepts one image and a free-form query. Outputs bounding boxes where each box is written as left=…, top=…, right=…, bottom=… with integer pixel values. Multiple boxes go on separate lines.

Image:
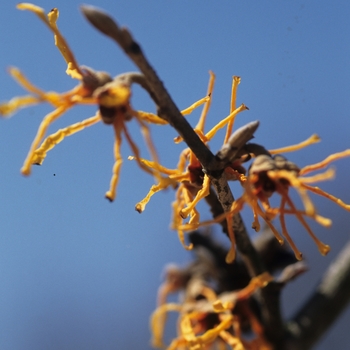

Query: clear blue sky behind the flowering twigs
left=0, top=0, right=350, bottom=350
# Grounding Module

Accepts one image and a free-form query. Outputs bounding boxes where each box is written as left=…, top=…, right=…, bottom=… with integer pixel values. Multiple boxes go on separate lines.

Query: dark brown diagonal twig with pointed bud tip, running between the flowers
left=81, top=6, right=282, bottom=348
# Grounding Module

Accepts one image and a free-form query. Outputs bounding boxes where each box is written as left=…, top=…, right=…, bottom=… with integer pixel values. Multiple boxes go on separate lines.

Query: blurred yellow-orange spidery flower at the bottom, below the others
left=151, top=273, right=272, bottom=350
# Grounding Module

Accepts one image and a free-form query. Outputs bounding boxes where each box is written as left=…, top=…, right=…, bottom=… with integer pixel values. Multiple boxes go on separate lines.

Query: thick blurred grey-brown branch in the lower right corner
left=286, top=242, right=350, bottom=350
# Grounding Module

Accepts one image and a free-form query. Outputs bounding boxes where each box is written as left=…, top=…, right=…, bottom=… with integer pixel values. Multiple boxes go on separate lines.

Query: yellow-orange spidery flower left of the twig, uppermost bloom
left=0, top=3, right=208, bottom=201
